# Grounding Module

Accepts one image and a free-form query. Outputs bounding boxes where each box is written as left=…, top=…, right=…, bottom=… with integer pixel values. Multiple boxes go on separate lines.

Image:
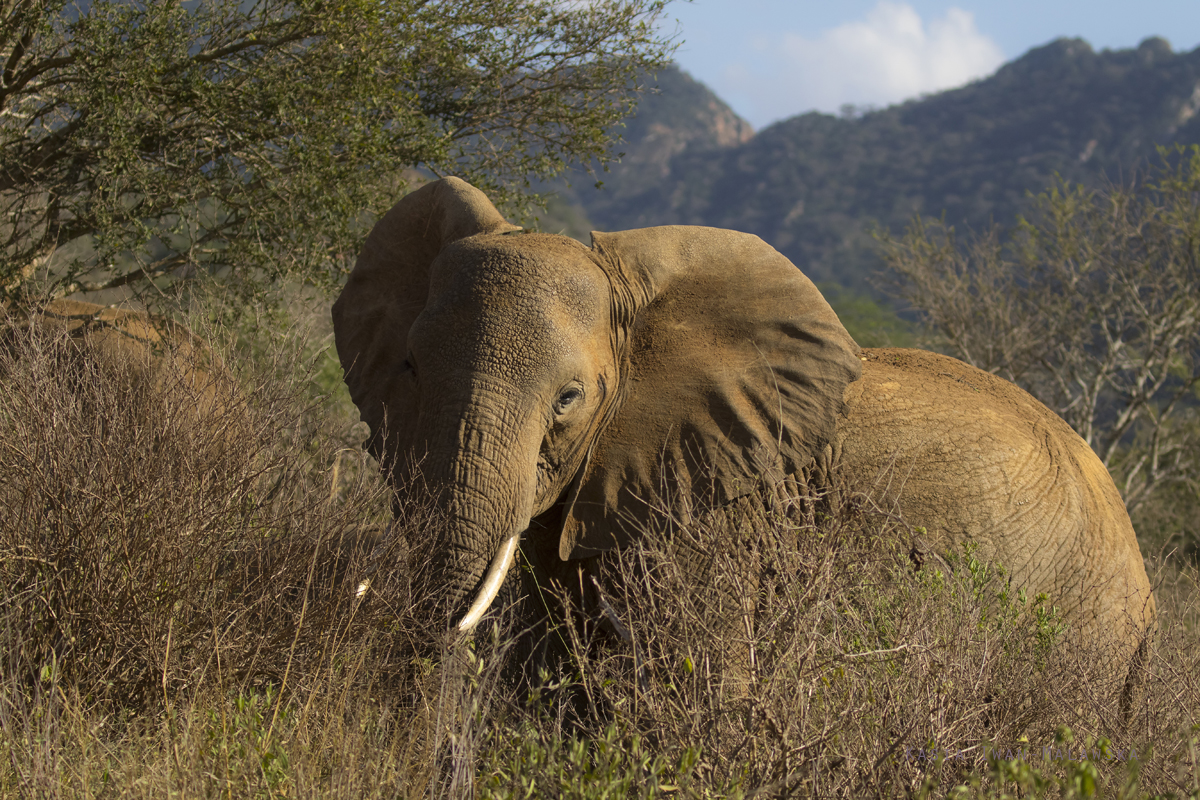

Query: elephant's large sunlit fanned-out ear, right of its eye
left=559, top=225, right=862, bottom=559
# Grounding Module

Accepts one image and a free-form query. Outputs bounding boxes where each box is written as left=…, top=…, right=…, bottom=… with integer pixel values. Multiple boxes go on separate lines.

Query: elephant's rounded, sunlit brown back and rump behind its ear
left=835, top=349, right=1154, bottom=658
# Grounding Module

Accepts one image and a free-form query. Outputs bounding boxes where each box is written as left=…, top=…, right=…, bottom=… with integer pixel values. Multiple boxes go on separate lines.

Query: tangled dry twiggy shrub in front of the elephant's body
left=484, top=494, right=1200, bottom=798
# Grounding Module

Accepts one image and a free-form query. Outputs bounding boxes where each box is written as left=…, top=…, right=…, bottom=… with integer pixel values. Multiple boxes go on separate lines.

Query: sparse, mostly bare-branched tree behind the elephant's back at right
left=882, top=146, right=1200, bottom=511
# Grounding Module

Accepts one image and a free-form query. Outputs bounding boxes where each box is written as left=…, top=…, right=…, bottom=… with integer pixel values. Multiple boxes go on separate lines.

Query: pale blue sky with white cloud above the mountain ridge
left=666, top=0, right=1200, bottom=128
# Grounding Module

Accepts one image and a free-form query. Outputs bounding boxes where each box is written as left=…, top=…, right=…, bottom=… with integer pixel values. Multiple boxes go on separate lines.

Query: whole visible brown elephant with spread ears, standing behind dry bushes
left=332, top=178, right=1154, bottom=705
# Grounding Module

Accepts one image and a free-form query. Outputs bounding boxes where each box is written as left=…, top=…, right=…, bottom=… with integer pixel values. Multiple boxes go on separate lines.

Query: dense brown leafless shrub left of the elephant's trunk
left=0, top=309, right=405, bottom=709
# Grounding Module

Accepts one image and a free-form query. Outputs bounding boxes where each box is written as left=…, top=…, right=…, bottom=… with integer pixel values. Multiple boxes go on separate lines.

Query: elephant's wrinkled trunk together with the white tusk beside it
left=421, top=386, right=540, bottom=632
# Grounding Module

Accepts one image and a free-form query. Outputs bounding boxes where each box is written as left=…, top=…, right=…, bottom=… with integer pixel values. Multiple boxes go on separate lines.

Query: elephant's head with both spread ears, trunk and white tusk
left=332, top=178, right=860, bottom=630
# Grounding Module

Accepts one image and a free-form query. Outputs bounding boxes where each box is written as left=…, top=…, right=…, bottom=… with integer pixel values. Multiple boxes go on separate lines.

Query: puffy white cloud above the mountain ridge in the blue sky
left=720, top=0, right=1004, bottom=126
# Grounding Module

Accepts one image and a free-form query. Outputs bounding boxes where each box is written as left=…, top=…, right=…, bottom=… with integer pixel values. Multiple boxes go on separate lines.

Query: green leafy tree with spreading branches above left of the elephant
left=0, top=0, right=670, bottom=303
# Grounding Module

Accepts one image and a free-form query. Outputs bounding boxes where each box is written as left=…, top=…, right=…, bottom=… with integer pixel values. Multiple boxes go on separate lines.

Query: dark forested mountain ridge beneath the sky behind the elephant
left=560, top=38, right=1200, bottom=290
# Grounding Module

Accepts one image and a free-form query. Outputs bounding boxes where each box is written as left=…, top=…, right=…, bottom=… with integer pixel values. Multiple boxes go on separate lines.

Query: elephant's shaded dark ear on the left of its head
left=332, top=178, right=521, bottom=468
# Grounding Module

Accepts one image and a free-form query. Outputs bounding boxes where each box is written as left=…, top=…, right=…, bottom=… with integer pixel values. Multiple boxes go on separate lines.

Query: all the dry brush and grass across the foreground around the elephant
left=0, top=297, right=1200, bottom=798
